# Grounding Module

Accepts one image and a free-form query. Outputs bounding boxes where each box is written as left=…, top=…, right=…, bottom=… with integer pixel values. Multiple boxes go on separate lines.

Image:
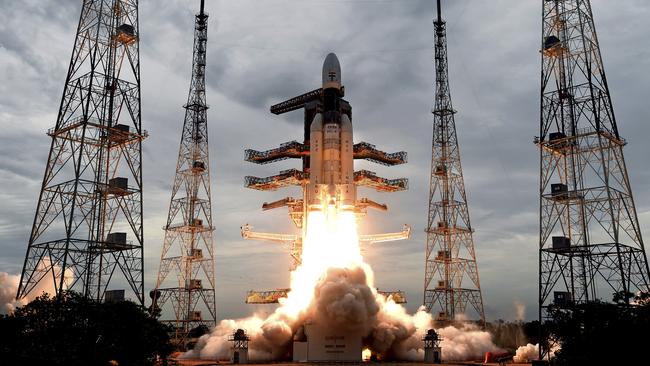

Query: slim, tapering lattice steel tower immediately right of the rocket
left=424, top=0, right=485, bottom=322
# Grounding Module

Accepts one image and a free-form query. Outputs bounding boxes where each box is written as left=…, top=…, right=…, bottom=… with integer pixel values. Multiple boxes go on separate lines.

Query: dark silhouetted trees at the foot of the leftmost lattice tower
left=0, top=293, right=172, bottom=366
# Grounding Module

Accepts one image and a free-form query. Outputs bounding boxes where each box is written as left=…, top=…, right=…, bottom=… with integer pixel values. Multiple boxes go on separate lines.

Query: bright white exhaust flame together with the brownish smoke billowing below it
left=184, top=212, right=498, bottom=361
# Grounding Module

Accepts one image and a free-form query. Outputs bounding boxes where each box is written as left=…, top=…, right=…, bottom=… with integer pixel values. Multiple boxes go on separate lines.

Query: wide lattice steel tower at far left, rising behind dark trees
left=17, top=0, right=147, bottom=304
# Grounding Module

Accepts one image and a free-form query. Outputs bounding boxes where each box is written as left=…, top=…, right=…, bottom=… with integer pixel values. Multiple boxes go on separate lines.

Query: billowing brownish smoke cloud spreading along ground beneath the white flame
left=184, top=264, right=499, bottom=361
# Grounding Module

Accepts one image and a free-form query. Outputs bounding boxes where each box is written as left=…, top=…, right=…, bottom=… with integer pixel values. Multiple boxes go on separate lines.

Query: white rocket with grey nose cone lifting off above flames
left=305, top=53, right=357, bottom=211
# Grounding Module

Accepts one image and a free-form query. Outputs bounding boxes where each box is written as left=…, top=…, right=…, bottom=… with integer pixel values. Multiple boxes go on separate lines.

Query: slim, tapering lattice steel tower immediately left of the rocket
left=151, top=0, right=216, bottom=347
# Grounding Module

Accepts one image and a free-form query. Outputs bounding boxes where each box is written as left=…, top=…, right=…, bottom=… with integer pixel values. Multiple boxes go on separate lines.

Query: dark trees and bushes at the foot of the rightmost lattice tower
left=487, top=293, right=650, bottom=366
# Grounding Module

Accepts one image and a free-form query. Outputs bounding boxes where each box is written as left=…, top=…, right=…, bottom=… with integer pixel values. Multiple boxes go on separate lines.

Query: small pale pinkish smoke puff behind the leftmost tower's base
left=0, top=259, right=73, bottom=314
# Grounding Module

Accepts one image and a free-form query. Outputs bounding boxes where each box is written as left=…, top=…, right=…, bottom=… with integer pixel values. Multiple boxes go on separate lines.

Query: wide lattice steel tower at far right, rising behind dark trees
left=535, top=0, right=649, bottom=355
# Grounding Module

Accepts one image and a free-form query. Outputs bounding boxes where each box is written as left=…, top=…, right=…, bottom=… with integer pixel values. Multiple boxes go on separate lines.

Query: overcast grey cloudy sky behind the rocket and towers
left=0, top=0, right=650, bottom=319
